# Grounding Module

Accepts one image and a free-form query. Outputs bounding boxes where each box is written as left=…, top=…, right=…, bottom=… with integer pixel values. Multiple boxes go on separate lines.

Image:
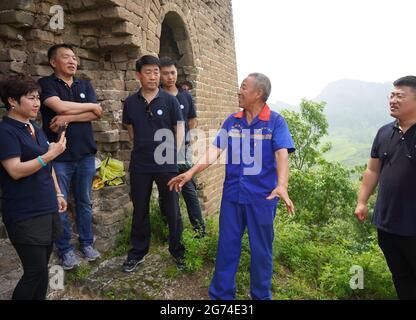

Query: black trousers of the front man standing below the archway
left=128, top=172, right=185, bottom=260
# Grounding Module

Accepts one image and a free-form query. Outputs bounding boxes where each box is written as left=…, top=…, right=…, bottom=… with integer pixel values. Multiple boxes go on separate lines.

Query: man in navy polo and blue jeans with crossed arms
left=39, top=44, right=102, bottom=270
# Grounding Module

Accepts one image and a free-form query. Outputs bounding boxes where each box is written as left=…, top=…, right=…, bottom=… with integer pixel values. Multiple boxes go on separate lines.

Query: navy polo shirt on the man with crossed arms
left=39, top=75, right=97, bottom=161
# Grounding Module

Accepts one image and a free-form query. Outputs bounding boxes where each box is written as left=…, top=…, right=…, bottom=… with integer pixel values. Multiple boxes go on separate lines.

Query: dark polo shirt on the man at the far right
left=371, top=122, right=416, bottom=236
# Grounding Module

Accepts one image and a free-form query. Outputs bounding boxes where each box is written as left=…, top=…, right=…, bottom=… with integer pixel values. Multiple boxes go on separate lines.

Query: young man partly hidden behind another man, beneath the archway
left=160, top=57, right=205, bottom=236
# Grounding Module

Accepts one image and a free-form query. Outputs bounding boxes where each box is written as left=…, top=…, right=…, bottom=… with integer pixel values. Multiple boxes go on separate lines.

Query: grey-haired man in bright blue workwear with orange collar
left=169, top=73, right=295, bottom=300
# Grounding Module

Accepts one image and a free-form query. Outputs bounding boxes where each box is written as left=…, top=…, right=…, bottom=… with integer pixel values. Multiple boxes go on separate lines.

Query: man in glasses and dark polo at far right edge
left=355, top=76, right=416, bottom=300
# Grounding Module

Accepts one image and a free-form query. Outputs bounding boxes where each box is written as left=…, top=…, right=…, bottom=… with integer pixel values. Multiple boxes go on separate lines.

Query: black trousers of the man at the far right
left=378, top=229, right=416, bottom=300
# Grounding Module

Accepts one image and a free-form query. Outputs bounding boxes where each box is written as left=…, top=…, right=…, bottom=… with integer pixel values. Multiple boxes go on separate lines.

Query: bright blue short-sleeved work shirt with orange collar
left=214, top=104, right=295, bottom=205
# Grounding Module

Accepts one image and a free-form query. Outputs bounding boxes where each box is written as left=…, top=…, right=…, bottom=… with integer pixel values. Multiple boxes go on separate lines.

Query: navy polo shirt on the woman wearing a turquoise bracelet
left=0, top=117, right=58, bottom=224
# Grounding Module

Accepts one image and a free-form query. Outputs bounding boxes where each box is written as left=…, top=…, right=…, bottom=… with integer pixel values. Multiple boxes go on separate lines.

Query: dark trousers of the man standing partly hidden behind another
left=159, top=165, right=205, bottom=234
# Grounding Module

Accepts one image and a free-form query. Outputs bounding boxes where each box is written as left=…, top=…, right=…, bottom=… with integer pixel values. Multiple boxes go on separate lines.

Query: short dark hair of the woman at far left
left=0, top=74, right=41, bottom=110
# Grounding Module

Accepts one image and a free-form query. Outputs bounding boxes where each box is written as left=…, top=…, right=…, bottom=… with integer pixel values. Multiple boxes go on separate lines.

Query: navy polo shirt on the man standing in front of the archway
left=123, top=90, right=183, bottom=173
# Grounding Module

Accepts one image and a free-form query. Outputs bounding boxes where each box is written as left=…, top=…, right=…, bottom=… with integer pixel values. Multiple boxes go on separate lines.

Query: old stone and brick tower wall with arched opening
left=0, top=0, right=238, bottom=249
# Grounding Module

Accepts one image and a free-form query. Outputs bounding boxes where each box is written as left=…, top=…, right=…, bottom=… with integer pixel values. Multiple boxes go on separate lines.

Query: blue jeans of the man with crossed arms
left=53, top=155, right=95, bottom=257
